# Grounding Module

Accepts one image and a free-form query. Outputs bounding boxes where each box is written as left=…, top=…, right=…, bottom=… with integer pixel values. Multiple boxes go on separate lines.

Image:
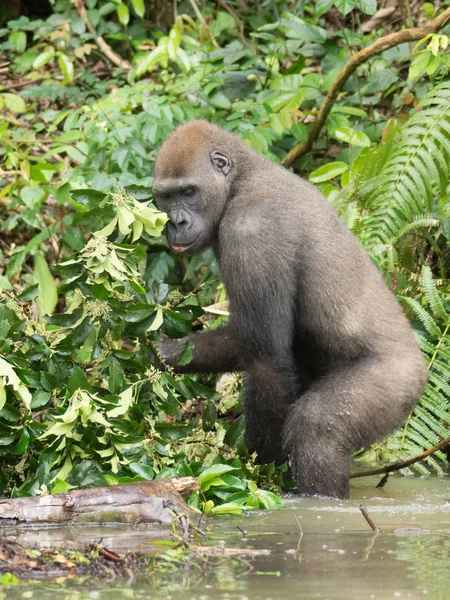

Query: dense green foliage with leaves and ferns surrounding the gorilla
left=0, top=0, right=450, bottom=513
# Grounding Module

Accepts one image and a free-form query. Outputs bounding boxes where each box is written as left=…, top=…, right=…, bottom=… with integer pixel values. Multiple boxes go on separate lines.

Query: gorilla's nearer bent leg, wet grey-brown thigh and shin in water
left=284, top=356, right=424, bottom=498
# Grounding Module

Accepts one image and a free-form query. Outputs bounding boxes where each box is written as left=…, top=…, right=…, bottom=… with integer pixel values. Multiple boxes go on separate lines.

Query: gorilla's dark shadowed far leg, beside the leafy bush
left=244, top=359, right=299, bottom=463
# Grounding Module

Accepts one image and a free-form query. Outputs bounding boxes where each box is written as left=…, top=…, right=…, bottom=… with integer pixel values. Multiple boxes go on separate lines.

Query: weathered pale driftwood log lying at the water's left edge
left=0, top=477, right=200, bottom=525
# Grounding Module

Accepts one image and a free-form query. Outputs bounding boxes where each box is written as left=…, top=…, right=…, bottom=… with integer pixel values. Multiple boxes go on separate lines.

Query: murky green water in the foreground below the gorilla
left=0, top=477, right=450, bottom=600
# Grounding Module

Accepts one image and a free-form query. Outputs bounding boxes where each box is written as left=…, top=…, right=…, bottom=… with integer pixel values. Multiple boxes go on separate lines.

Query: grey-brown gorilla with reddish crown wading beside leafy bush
left=153, top=120, right=427, bottom=498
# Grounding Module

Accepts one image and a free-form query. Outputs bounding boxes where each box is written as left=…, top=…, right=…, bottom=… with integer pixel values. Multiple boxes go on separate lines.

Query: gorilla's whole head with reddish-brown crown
left=153, top=121, right=237, bottom=253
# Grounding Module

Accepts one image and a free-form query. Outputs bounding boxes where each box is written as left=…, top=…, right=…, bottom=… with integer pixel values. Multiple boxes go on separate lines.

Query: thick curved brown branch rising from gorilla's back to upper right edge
left=282, top=8, right=450, bottom=166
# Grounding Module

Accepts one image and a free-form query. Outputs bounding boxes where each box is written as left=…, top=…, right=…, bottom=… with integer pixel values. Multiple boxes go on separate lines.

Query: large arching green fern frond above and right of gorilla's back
left=355, top=82, right=450, bottom=267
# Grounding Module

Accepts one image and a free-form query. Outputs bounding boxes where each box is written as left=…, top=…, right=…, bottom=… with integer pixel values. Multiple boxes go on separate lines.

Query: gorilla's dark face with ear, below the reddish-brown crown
left=153, top=151, right=231, bottom=253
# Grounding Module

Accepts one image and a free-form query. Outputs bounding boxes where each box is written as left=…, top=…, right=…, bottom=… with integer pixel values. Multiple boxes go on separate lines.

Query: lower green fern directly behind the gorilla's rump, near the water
left=387, top=267, right=450, bottom=474
